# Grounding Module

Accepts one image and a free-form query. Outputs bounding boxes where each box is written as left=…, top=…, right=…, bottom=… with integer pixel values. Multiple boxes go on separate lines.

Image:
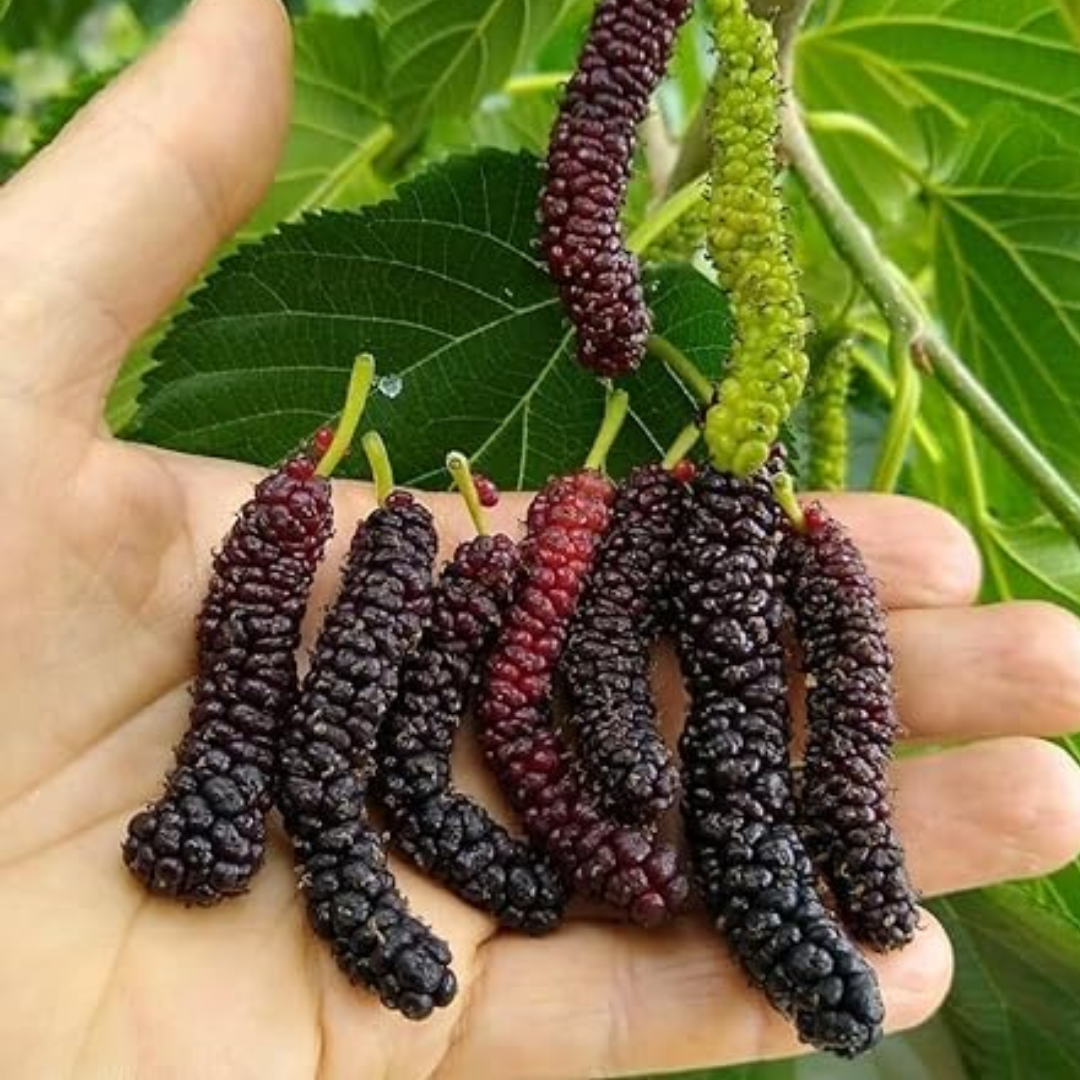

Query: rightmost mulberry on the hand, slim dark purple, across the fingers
left=780, top=507, right=919, bottom=950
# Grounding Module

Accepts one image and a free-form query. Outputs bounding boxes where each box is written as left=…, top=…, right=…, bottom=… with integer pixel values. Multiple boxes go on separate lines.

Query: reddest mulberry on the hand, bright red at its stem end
left=477, top=471, right=688, bottom=926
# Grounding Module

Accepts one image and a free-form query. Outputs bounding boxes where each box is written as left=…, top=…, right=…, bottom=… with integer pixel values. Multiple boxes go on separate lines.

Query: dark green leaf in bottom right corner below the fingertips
left=931, top=887, right=1080, bottom=1080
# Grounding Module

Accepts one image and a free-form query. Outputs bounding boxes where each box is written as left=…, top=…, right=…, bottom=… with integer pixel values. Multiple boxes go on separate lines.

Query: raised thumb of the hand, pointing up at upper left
left=0, top=0, right=291, bottom=419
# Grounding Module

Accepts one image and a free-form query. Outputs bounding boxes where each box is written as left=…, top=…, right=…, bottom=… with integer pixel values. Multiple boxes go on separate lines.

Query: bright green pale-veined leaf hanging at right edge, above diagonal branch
left=934, top=106, right=1080, bottom=509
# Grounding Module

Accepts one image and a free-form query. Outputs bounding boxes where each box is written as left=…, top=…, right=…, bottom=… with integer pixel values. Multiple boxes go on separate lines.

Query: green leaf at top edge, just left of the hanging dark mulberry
left=380, top=0, right=566, bottom=122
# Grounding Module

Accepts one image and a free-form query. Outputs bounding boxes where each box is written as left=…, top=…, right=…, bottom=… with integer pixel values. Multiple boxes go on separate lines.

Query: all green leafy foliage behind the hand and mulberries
left=0, top=0, right=1080, bottom=1080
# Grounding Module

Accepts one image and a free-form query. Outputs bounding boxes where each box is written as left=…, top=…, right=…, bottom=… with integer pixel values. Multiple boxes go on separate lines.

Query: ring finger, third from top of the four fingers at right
left=893, top=739, right=1080, bottom=896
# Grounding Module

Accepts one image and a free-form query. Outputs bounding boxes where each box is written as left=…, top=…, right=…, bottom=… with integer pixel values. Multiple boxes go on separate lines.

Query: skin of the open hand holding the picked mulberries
left=0, top=0, right=1080, bottom=1080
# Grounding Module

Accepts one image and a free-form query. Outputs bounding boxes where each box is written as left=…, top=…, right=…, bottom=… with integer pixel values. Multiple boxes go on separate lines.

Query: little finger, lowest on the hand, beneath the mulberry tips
left=443, top=915, right=951, bottom=1080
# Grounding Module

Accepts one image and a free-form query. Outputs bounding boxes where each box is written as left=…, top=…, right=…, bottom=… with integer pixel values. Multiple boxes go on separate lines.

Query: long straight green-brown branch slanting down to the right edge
left=782, top=105, right=1080, bottom=544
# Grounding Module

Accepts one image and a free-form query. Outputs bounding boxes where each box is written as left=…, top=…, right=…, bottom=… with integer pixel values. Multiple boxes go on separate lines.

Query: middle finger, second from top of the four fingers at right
left=889, top=602, right=1080, bottom=739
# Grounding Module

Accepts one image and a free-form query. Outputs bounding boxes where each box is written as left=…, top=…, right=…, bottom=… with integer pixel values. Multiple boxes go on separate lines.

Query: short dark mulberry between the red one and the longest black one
left=561, top=464, right=685, bottom=823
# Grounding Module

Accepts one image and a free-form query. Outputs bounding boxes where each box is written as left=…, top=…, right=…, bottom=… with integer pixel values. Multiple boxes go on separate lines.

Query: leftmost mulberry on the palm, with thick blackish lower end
left=123, top=458, right=334, bottom=904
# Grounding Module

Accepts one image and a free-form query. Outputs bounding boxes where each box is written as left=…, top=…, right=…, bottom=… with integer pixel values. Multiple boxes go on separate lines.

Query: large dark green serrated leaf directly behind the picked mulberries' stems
left=132, top=151, right=728, bottom=488
